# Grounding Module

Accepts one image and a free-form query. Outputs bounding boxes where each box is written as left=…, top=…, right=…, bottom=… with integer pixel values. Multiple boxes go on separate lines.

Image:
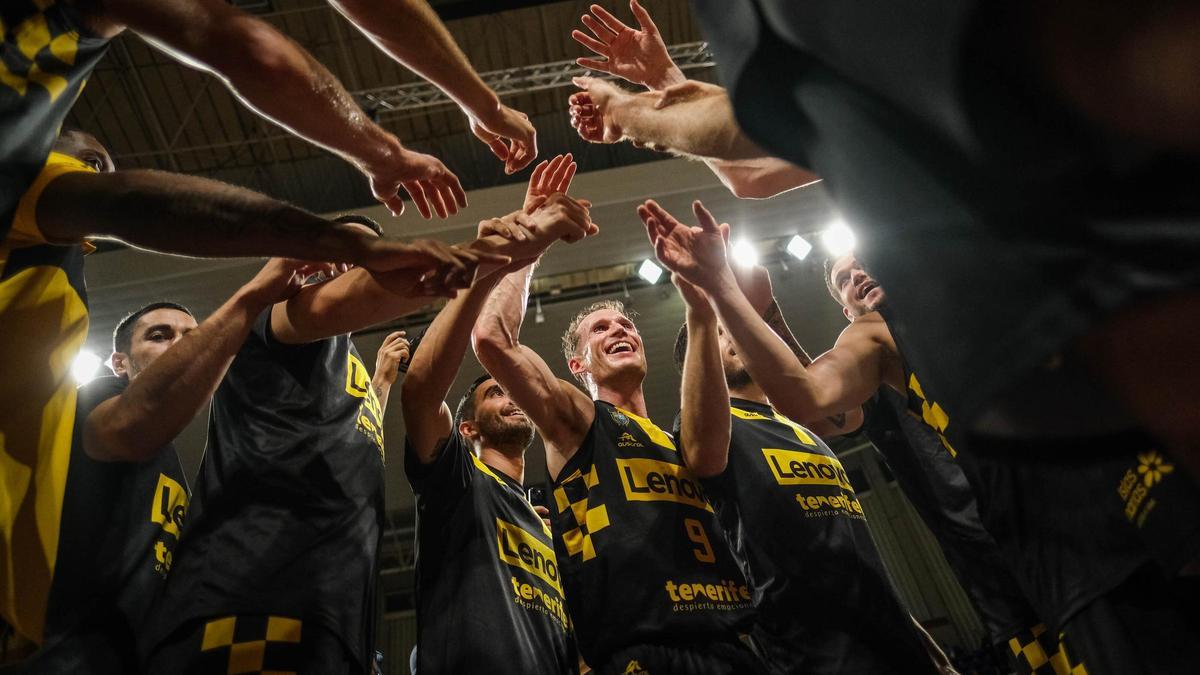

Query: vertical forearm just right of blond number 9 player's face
left=679, top=310, right=730, bottom=478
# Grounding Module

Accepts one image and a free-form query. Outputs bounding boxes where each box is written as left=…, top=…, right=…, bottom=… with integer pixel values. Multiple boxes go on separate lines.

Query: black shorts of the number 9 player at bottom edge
left=589, top=641, right=770, bottom=675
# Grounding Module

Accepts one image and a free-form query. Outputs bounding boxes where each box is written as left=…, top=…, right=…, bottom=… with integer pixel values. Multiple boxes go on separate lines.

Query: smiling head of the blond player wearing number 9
left=566, top=307, right=646, bottom=384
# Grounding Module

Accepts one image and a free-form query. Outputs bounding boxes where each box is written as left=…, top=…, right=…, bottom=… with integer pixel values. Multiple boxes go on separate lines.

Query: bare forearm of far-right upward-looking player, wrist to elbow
left=709, top=279, right=838, bottom=420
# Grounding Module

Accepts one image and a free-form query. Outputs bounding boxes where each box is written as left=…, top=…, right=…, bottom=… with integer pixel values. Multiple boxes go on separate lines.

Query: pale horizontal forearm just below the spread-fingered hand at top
left=611, top=92, right=764, bottom=160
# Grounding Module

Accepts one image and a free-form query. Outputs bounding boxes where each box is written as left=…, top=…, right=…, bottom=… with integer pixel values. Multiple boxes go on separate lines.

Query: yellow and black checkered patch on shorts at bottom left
left=200, top=616, right=301, bottom=675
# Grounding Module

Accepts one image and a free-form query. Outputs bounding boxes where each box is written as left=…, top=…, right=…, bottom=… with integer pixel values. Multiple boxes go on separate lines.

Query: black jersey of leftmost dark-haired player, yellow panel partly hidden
left=15, top=377, right=187, bottom=675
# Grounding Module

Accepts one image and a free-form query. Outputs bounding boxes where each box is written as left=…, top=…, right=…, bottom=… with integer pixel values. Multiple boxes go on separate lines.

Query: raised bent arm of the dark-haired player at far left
left=83, top=258, right=311, bottom=461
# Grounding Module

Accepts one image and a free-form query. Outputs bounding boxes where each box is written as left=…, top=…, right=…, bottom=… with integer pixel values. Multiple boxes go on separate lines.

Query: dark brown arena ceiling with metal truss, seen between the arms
left=67, top=0, right=715, bottom=213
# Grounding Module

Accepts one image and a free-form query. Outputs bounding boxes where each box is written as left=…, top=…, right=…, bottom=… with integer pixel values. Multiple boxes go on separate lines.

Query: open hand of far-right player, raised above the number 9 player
left=637, top=199, right=734, bottom=285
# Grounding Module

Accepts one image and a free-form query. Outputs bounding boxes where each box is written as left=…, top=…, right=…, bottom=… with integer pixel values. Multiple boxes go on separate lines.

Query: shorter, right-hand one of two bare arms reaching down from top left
left=330, top=0, right=538, bottom=173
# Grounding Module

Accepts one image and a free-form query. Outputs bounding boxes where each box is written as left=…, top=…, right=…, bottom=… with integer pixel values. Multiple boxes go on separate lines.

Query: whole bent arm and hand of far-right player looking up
left=638, top=202, right=883, bottom=420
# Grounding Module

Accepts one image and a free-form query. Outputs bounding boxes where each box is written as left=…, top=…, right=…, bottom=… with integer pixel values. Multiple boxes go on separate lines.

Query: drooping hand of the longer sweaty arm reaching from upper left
left=362, top=148, right=467, bottom=219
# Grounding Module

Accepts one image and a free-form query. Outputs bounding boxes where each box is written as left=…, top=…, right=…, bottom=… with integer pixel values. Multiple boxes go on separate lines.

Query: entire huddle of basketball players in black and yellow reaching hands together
left=0, top=0, right=1200, bottom=675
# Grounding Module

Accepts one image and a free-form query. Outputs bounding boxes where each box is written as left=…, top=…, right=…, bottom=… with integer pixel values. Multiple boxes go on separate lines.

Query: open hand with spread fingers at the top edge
left=571, top=0, right=684, bottom=89
